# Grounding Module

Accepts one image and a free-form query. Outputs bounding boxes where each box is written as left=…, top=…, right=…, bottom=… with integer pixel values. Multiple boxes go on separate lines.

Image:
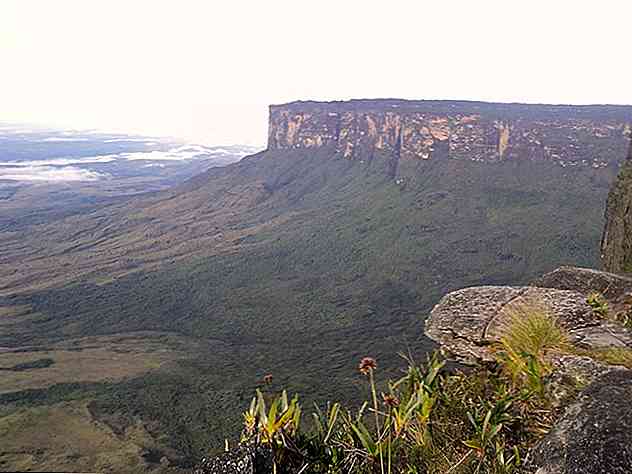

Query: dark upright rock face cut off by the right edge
left=601, top=140, right=632, bottom=273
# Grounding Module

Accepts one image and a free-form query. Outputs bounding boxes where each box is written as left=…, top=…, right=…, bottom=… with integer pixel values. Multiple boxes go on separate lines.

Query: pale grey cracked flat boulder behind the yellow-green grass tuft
left=425, top=286, right=632, bottom=362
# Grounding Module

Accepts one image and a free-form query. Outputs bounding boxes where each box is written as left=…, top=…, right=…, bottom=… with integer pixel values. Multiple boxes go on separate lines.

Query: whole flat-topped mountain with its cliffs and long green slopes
left=0, top=101, right=632, bottom=471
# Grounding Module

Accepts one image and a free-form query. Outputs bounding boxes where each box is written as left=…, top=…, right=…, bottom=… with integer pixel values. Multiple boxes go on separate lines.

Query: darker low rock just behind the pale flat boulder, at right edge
left=531, top=266, right=632, bottom=298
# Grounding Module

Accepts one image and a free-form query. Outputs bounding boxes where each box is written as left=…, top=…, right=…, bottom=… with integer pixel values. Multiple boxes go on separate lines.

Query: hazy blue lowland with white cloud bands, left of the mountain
left=0, top=124, right=258, bottom=183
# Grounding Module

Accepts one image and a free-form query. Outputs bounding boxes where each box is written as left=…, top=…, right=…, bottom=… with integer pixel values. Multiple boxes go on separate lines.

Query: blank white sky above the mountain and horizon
left=0, top=0, right=632, bottom=144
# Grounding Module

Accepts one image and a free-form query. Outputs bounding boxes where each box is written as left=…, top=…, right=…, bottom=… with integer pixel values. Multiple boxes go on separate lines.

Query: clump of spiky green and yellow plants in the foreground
left=227, top=306, right=596, bottom=474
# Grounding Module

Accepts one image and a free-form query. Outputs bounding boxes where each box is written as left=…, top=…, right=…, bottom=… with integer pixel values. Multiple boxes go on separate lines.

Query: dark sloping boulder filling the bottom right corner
left=528, top=370, right=632, bottom=474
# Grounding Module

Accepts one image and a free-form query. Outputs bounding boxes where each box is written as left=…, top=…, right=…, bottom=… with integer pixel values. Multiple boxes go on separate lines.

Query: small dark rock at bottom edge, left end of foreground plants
left=193, top=445, right=272, bottom=474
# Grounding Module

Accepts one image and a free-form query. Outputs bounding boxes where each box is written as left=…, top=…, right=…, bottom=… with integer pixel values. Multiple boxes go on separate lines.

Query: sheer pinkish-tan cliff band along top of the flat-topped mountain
left=268, top=100, right=632, bottom=168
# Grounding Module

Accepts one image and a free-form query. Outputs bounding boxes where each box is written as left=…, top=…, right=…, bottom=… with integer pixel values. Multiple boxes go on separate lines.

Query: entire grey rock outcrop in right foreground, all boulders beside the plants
left=425, top=267, right=632, bottom=474
